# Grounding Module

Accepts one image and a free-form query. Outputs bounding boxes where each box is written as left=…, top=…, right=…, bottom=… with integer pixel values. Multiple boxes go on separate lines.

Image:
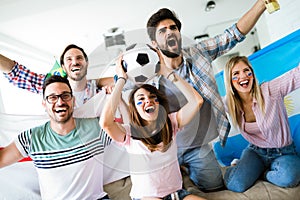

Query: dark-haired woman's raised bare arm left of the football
left=100, top=57, right=127, bottom=142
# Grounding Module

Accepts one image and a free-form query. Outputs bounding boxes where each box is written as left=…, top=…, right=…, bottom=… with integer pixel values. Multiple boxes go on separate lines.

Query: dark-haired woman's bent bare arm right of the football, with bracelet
left=159, top=52, right=203, bottom=128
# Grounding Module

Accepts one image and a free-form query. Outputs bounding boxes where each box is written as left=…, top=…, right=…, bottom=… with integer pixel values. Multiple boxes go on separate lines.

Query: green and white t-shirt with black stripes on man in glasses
left=15, top=118, right=111, bottom=199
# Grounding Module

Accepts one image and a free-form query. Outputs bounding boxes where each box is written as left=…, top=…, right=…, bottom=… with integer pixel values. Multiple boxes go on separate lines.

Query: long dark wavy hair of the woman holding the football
left=129, top=84, right=173, bottom=152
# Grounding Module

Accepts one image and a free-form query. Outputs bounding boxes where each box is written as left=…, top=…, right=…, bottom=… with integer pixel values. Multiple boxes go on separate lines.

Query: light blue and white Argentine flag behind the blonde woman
left=213, top=29, right=300, bottom=166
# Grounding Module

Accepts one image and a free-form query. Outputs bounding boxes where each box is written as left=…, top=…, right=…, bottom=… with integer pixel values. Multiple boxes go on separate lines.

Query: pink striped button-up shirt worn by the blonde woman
left=241, top=65, right=300, bottom=148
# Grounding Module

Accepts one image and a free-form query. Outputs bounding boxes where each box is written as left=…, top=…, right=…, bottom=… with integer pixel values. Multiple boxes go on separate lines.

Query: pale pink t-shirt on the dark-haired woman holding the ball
left=120, top=113, right=182, bottom=198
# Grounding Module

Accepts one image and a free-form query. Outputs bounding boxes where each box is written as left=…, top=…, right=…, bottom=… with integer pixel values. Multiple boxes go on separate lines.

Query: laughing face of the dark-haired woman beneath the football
left=134, top=88, right=159, bottom=122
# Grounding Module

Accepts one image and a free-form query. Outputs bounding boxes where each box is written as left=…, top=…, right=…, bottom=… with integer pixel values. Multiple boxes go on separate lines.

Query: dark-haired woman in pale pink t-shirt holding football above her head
left=100, top=52, right=203, bottom=199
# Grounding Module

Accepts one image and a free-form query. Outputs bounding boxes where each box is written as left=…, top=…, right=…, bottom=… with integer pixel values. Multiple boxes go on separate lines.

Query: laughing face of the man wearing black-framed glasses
left=43, top=82, right=74, bottom=123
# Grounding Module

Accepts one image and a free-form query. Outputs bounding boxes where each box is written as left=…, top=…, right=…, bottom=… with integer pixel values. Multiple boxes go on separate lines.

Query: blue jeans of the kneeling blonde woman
left=224, top=144, right=300, bottom=192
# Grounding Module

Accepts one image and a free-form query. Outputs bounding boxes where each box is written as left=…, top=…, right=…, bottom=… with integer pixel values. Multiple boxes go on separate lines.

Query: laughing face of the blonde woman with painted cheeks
left=231, top=61, right=254, bottom=94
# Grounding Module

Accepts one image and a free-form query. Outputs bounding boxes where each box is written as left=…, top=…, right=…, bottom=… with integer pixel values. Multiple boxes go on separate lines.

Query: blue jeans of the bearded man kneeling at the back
left=177, top=144, right=224, bottom=191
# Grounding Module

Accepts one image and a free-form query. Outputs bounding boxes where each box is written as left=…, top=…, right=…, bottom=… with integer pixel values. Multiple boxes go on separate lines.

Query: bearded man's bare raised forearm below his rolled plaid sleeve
left=237, top=0, right=266, bottom=35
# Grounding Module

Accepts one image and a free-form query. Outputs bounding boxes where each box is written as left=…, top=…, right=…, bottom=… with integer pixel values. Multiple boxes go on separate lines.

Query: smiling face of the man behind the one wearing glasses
left=62, top=48, right=88, bottom=81
